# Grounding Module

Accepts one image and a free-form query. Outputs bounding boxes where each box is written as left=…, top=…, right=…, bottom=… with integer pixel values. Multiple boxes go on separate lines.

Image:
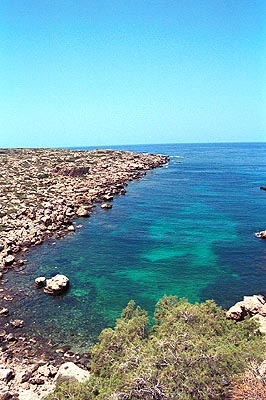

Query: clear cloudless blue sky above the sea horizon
left=0, top=0, right=266, bottom=147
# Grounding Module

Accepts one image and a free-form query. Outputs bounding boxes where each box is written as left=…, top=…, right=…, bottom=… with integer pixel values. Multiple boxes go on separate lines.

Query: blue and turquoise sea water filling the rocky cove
left=3, top=143, right=266, bottom=347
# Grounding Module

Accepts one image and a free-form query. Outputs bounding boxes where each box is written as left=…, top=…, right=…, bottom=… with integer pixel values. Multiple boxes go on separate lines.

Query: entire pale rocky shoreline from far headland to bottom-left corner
left=0, top=149, right=169, bottom=400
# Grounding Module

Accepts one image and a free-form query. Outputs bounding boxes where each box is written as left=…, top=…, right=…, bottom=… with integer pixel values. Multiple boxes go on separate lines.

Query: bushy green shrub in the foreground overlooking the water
left=49, top=296, right=264, bottom=400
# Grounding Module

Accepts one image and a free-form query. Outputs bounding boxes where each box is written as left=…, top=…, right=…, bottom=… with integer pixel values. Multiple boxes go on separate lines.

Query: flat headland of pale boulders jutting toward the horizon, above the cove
left=0, top=149, right=169, bottom=272
